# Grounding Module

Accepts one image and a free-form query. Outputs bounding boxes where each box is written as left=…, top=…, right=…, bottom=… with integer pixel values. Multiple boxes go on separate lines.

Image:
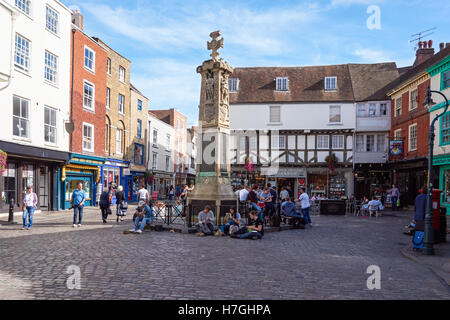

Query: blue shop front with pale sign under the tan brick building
left=102, top=159, right=130, bottom=204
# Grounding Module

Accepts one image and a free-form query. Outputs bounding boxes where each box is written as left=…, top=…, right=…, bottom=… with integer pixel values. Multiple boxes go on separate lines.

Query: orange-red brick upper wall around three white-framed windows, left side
left=71, top=30, right=107, bottom=157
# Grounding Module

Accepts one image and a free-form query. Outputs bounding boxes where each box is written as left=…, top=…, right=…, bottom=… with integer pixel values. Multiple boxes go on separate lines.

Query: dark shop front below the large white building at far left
left=0, top=141, right=69, bottom=213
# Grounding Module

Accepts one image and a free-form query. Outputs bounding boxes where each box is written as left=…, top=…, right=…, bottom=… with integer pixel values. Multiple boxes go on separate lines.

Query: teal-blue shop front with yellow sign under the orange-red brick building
left=61, top=154, right=105, bottom=209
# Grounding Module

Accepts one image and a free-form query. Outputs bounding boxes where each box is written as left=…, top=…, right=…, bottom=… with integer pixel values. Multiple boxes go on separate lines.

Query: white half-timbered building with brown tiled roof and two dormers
left=229, top=65, right=356, bottom=199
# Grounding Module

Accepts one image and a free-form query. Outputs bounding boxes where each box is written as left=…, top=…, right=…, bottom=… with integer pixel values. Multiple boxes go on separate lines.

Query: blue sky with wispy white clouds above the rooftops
left=62, top=0, right=450, bottom=125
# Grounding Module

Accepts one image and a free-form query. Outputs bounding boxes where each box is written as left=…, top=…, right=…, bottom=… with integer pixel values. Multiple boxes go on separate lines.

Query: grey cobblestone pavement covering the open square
left=0, top=209, right=450, bottom=299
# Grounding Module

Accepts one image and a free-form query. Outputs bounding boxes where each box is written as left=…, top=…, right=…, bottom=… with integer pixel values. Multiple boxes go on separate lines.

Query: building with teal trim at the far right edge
left=427, top=43, right=450, bottom=215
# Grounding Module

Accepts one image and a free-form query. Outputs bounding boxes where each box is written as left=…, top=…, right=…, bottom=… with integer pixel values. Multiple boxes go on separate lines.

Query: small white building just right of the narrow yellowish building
left=147, top=111, right=176, bottom=198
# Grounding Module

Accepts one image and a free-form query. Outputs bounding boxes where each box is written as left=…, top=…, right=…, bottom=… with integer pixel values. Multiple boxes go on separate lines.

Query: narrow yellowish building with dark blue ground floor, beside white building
left=124, top=84, right=148, bottom=202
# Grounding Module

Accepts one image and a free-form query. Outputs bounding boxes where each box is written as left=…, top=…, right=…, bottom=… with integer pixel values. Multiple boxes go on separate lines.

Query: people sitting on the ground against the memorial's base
left=196, top=206, right=264, bottom=240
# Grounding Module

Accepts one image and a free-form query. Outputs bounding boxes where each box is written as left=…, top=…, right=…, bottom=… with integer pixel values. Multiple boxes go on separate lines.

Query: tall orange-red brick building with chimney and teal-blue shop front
left=61, top=11, right=107, bottom=209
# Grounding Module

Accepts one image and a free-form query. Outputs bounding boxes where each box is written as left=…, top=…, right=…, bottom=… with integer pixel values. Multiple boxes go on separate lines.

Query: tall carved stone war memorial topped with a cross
left=188, top=31, right=236, bottom=223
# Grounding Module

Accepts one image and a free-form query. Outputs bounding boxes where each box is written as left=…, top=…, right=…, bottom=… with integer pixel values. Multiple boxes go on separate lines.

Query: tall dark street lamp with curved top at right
left=423, top=87, right=448, bottom=255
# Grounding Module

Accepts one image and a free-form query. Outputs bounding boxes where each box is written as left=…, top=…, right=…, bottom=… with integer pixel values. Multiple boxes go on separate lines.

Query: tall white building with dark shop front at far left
left=0, top=0, right=71, bottom=212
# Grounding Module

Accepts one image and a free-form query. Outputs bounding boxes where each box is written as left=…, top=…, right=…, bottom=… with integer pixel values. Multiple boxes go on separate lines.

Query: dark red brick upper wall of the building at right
left=391, top=79, right=430, bottom=159
